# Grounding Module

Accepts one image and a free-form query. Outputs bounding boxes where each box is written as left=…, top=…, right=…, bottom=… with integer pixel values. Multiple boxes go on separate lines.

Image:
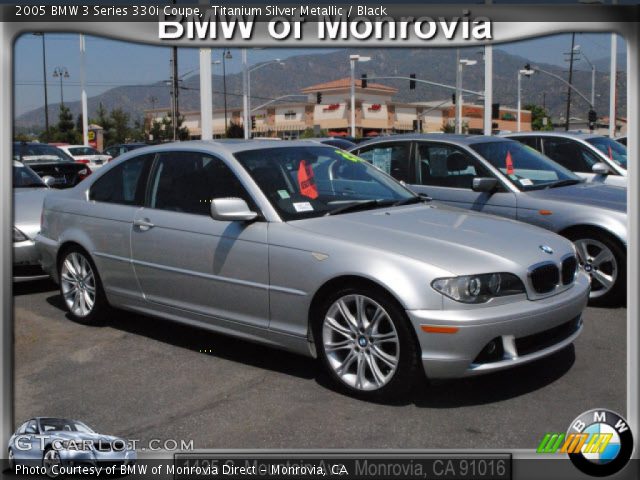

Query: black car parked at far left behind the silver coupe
left=13, top=142, right=91, bottom=188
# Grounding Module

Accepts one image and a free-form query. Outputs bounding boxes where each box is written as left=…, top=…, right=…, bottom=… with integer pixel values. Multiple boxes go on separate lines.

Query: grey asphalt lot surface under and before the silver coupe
left=14, top=282, right=626, bottom=449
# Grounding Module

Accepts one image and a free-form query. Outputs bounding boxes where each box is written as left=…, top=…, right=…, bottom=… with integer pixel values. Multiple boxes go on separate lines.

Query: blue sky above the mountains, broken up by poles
left=14, top=33, right=625, bottom=115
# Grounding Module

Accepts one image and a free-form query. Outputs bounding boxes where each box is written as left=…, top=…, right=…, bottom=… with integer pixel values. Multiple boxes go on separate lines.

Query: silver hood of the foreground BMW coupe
left=290, top=204, right=573, bottom=275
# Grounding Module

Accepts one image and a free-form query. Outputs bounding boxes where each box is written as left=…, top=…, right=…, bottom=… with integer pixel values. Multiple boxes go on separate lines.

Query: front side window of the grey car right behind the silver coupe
left=415, top=143, right=494, bottom=190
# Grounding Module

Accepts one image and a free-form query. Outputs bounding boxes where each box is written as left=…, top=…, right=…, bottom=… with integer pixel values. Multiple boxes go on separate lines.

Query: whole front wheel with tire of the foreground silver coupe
left=312, top=287, right=418, bottom=400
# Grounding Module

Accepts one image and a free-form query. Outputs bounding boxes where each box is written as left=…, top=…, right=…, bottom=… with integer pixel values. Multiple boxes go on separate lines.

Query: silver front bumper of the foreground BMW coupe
left=407, top=272, right=589, bottom=378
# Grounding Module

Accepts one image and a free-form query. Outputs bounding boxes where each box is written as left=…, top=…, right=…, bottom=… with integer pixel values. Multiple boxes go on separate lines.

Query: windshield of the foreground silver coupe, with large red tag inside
left=235, top=146, right=420, bottom=221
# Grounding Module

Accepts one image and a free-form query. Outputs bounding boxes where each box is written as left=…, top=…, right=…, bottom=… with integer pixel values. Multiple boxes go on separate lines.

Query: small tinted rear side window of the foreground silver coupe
left=89, top=153, right=155, bottom=206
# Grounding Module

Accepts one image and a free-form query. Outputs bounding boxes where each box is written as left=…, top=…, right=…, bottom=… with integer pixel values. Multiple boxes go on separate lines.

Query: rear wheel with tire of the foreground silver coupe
left=58, top=246, right=109, bottom=325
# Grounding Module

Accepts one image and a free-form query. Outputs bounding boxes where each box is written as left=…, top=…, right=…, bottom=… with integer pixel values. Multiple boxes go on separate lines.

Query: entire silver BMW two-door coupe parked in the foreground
left=37, top=141, right=589, bottom=397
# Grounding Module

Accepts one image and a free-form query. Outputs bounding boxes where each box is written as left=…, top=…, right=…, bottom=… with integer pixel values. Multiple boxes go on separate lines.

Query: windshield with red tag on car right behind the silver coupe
left=471, top=140, right=581, bottom=191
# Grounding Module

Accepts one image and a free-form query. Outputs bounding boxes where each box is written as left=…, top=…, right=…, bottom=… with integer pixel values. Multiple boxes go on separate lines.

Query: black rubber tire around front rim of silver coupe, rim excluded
left=312, top=287, right=419, bottom=400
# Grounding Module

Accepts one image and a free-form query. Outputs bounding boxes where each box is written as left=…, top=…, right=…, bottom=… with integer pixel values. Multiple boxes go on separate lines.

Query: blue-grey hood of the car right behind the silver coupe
left=527, top=182, right=627, bottom=212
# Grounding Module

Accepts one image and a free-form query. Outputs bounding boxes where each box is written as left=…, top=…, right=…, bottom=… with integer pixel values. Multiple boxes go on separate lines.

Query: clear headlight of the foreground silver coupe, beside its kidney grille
left=431, top=273, right=526, bottom=303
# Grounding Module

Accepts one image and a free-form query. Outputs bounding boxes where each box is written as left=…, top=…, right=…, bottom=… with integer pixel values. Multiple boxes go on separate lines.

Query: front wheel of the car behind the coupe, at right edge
left=568, top=229, right=627, bottom=306
